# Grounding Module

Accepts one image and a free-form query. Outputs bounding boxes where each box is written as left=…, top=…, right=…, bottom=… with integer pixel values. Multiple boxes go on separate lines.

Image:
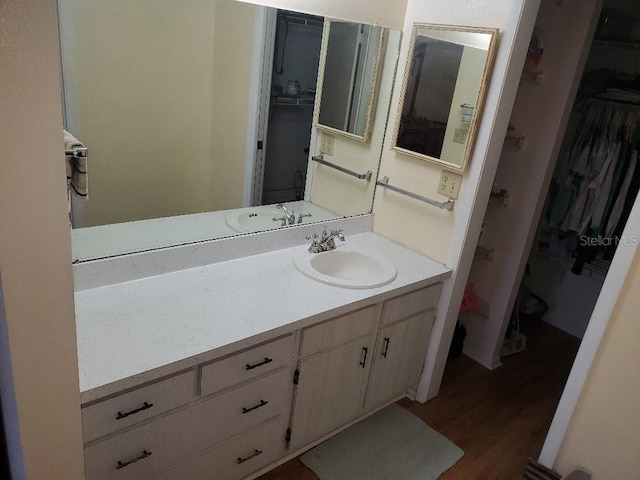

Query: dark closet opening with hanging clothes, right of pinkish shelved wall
left=529, top=2, right=640, bottom=338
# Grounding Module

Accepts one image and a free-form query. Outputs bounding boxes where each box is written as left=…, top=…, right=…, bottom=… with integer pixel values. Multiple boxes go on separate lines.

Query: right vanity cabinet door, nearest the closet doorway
left=365, top=311, right=436, bottom=408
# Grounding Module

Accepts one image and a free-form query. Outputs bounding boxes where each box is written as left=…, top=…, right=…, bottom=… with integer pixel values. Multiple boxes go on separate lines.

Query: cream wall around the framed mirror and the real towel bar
left=373, top=0, right=511, bottom=263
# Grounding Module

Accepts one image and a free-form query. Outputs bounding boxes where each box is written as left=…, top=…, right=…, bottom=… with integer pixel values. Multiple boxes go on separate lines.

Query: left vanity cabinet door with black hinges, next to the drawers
left=290, top=335, right=372, bottom=449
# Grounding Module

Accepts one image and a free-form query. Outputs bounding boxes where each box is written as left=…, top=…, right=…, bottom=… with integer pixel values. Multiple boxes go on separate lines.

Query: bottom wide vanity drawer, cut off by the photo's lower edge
left=153, top=417, right=287, bottom=480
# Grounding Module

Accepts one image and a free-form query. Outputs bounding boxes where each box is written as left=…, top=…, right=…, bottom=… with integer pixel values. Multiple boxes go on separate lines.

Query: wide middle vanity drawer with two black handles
left=85, top=369, right=291, bottom=480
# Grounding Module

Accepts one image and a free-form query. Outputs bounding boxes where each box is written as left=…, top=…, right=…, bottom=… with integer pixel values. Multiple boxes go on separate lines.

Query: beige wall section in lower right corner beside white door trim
left=555, top=254, right=640, bottom=480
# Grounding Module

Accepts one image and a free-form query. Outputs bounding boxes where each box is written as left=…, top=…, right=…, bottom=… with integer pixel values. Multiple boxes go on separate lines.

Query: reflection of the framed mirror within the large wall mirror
left=314, top=20, right=386, bottom=142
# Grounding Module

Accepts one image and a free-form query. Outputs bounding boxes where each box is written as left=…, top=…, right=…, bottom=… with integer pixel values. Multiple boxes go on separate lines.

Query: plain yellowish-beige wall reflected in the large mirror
left=60, top=0, right=254, bottom=226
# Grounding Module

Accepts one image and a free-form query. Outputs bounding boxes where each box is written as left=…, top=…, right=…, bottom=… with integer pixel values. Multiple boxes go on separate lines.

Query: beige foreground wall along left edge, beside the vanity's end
left=0, top=0, right=84, bottom=480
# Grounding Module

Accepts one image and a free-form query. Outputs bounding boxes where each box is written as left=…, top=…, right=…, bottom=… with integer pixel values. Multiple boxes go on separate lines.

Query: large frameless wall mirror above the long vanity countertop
left=58, top=0, right=400, bottom=262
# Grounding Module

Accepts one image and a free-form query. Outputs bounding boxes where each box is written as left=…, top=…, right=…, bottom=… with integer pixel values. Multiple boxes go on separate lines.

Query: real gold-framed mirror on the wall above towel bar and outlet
left=392, top=24, right=498, bottom=172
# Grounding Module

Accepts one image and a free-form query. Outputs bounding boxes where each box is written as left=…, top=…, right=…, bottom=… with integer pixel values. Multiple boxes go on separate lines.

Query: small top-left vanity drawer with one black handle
left=82, top=370, right=196, bottom=443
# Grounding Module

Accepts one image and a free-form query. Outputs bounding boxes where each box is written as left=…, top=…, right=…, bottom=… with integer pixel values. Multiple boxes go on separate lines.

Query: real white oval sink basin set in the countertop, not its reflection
left=293, top=243, right=397, bottom=288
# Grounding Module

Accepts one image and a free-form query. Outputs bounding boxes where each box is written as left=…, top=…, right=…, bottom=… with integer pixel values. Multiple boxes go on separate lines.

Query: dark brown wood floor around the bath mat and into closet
left=260, top=321, right=580, bottom=480
